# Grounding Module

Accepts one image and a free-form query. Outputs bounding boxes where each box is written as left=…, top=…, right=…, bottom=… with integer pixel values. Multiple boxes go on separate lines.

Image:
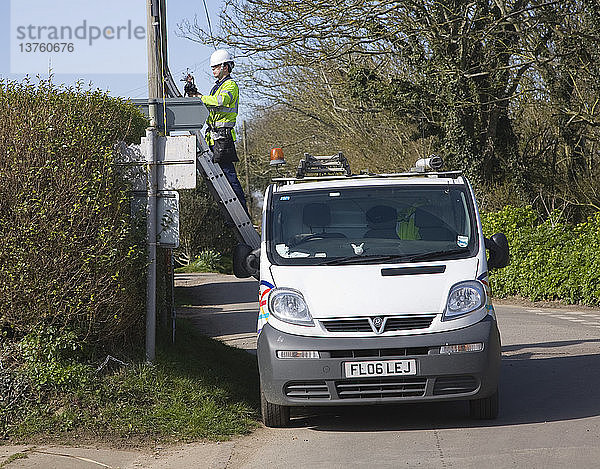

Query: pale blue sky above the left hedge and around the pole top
left=0, top=0, right=223, bottom=98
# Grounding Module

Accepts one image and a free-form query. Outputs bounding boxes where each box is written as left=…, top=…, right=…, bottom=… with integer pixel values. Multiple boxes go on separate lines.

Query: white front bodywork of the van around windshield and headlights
left=257, top=176, right=494, bottom=337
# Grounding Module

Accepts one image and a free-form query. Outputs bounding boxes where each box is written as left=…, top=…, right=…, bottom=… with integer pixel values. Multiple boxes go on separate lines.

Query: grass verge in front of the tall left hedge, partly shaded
left=5, top=321, right=259, bottom=445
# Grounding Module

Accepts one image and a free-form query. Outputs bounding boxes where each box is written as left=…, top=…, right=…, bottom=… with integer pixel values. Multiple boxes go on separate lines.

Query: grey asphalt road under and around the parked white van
left=180, top=277, right=600, bottom=469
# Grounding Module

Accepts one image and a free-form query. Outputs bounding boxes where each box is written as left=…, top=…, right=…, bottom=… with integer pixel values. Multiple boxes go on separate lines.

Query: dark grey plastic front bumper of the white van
left=258, top=316, right=501, bottom=406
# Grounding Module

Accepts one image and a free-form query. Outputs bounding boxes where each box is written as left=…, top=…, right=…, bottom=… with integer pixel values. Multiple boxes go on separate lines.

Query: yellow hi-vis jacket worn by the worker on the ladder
left=201, top=76, right=240, bottom=145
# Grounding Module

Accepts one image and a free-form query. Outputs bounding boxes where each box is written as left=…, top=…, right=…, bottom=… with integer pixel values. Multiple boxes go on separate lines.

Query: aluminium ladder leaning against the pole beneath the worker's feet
left=165, top=69, right=260, bottom=250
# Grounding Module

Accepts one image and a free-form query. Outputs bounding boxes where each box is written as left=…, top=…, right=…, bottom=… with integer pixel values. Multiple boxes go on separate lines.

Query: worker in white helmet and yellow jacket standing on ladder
left=185, top=49, right=248, bottom=213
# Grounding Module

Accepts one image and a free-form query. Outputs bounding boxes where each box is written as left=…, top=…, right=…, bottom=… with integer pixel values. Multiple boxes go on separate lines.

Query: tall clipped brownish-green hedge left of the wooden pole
left=0, top=81, right=146, bottom=343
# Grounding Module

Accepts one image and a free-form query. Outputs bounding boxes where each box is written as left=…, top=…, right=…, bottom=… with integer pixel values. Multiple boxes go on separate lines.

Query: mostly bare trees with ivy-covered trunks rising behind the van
left=180, top=0, right=600, bottom=218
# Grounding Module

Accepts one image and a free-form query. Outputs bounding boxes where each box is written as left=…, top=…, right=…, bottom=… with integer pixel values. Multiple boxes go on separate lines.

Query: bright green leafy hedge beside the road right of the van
left=482, top=206, right=600, bottom=305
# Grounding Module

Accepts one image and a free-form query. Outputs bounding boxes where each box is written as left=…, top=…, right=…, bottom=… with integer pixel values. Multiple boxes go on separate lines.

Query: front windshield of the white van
left=267, top=185, right=478, bottom=265
